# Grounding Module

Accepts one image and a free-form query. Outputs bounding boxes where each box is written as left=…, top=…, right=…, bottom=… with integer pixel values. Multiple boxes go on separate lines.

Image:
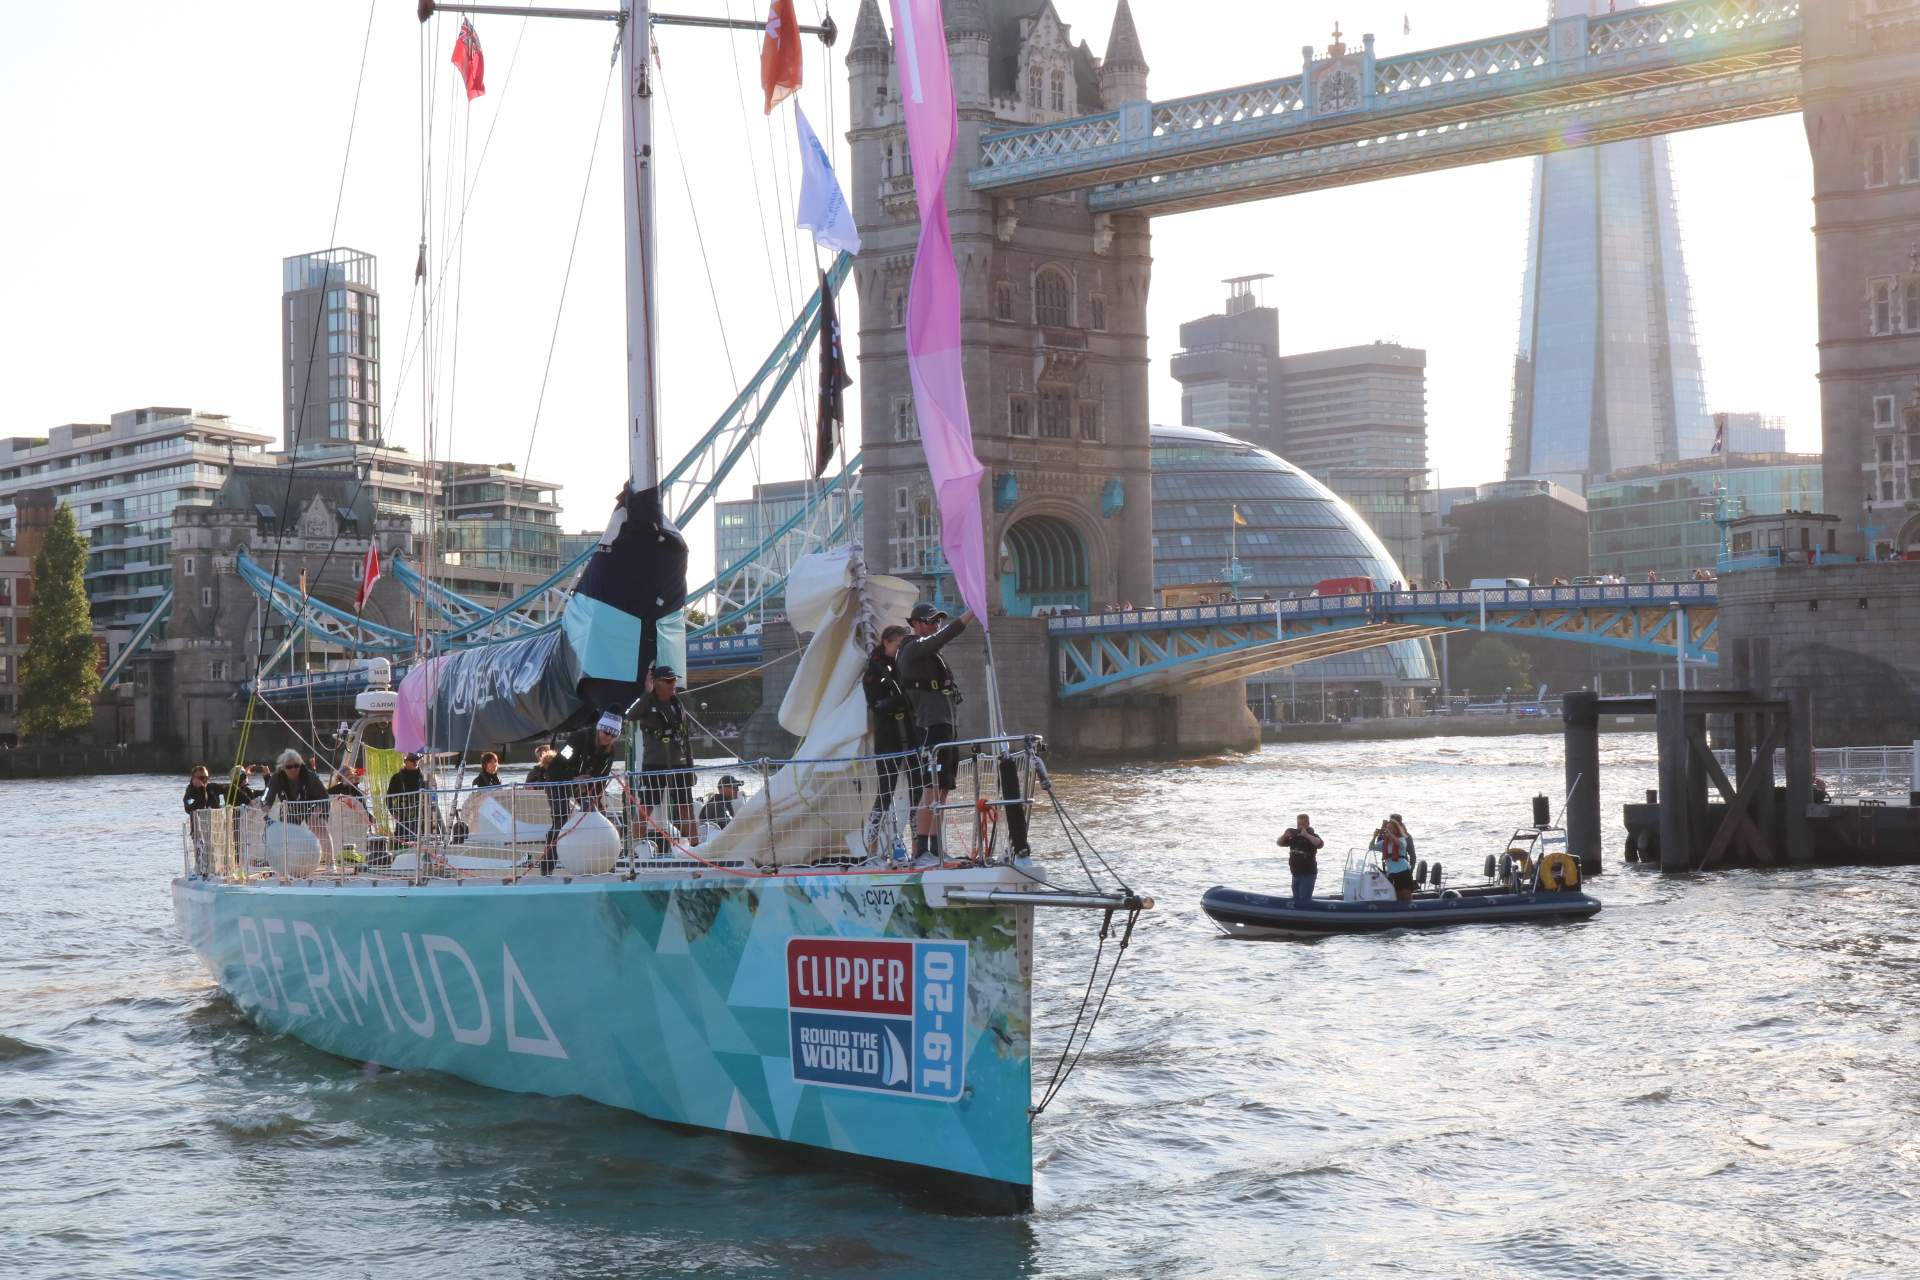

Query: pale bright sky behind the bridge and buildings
left=0, top=0, right=1820, bottom=570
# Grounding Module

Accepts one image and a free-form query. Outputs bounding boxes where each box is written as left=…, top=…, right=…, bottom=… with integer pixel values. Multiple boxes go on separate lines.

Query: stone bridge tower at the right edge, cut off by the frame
left=1801, top=0, right=1920, bottom=558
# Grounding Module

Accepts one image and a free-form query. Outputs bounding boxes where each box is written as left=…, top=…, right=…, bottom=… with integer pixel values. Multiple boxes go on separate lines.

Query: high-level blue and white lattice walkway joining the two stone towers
left=968, top=0, right=1803, bottom=213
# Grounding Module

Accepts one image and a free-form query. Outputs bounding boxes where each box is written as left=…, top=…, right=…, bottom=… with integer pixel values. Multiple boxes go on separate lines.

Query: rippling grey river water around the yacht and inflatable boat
left=0, top=735, right=1920, bottom=1280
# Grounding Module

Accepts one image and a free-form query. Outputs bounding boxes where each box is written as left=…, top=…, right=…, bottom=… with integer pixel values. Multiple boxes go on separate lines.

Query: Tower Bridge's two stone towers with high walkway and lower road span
left=848, top=0, right=1920, bottom=747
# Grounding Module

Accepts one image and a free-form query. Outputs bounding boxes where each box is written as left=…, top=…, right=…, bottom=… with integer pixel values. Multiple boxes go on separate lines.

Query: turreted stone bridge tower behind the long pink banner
left=847, top=0, right=1154, bottom=616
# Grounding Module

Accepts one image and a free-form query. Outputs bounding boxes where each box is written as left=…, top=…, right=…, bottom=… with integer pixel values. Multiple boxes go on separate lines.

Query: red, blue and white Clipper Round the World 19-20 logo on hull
left=787, top=938, right=966, bottom=1102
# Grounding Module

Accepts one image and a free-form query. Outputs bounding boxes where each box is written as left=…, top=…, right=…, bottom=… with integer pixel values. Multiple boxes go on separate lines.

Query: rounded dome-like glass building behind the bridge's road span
left=1142, top=426, right=1438, bottom=720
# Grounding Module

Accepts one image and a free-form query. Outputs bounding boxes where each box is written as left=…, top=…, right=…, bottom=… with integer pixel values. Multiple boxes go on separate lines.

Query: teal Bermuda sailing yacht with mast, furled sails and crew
left=173, top=0, right=1152, bottom=1211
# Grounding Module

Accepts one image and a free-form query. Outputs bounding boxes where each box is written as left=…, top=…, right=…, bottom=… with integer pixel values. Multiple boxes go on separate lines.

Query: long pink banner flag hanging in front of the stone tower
left=893, top=0, right=987, bottom=626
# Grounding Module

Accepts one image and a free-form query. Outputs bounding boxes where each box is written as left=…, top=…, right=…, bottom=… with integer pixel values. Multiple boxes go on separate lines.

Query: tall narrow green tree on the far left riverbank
left=19, top=503, right=100, bottom=743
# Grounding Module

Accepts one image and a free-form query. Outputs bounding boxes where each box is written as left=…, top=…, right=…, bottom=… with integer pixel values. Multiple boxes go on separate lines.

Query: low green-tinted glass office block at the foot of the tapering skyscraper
left=1586, top=453, right=1822, bottom=580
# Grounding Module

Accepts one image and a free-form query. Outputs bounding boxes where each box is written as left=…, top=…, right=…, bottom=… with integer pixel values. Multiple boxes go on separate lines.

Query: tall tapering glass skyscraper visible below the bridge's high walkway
left=1507, top=138, right=1713, bottom=493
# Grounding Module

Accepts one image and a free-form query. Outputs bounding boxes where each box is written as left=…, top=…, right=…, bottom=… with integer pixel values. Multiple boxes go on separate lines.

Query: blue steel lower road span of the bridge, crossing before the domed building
left=1046, top=581, right=1720, bottom=697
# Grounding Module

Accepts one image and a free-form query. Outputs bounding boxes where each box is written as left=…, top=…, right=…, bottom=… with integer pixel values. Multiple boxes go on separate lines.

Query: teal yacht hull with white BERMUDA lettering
left=173, top=873, right=1033, bottom=1211
